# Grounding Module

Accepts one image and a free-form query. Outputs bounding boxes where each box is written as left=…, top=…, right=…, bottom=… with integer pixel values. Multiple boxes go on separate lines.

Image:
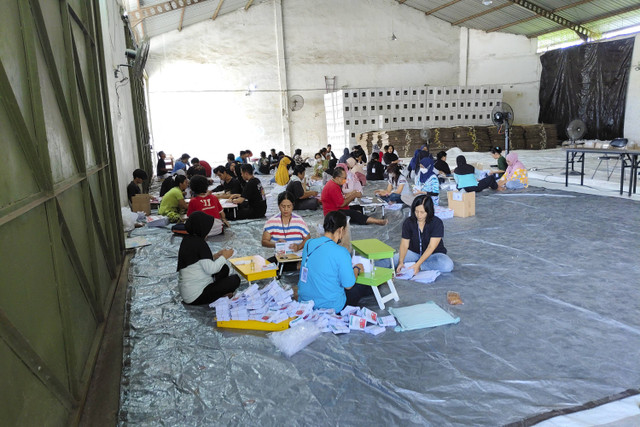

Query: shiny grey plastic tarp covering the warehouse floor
left=120, top=184, right=640, bottom=426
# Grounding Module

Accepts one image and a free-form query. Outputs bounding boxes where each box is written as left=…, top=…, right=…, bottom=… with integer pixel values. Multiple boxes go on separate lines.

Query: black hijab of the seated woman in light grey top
left=177, top=211, right=214, bottom=271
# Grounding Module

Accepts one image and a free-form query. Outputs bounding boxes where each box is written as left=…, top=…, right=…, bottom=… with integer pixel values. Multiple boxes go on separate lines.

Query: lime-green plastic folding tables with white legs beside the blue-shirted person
left=351, top=239, right=400, bottom=310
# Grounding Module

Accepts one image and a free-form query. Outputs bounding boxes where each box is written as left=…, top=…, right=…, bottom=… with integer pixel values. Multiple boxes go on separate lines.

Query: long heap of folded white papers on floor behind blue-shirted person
left=209, top=280, right=396, bottom=335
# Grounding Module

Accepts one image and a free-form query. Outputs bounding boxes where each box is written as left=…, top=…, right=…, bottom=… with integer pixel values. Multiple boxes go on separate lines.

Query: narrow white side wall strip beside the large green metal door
left=99, top=0, right=140, bottom=206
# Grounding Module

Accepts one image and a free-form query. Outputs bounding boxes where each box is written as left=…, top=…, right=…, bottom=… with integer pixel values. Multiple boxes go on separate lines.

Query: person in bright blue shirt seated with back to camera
left=298, top=211, right=373, bottom=313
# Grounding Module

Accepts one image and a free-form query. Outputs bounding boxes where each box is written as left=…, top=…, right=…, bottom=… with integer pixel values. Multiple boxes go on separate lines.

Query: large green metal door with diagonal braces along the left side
left=0, top=0, right=150, bottom=426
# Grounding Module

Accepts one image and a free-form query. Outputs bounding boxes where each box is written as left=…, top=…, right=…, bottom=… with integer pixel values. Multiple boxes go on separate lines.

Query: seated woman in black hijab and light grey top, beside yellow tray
left=178, top=211, right=240, bottom=305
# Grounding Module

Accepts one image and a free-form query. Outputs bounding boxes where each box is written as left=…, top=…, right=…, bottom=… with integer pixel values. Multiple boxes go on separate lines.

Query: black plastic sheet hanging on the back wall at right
left=538, top=37, right=635, bottom=140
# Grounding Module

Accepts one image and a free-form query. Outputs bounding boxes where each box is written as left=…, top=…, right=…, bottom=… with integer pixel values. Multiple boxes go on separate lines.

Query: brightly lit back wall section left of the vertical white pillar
left=147, top=3, right=284, bottom=165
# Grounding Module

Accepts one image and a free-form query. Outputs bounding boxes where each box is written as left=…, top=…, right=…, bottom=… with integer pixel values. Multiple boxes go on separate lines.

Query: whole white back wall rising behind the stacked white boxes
left=147, top=0, right=540, bottom=163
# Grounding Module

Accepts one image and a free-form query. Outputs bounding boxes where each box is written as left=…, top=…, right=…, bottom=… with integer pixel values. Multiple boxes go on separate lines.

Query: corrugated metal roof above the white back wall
left=124, top=0, right=640, bottom=44
